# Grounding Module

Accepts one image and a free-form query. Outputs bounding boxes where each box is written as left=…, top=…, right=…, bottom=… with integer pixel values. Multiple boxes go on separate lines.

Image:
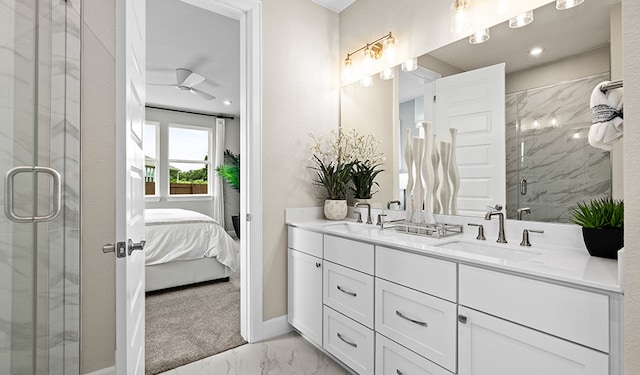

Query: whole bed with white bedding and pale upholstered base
left=144, top=208, right=238, bottom=292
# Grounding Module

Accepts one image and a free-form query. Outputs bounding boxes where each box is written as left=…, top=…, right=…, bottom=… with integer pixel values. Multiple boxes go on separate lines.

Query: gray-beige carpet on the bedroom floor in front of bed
left=145, top=274, right=245, bottom=374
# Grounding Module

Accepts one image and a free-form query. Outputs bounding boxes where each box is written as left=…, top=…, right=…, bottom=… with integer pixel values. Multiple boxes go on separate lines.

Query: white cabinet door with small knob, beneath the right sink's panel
left=458, top=306, right=609, bottom=375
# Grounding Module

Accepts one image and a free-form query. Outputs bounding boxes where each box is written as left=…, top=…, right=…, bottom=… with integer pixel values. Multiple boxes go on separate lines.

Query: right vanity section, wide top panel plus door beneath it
left=458, top=265, right=613, bottom=375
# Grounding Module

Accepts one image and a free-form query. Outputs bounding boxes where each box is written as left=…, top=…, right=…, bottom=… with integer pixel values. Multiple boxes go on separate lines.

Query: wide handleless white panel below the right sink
left=460, top=265, right=609, bottom=353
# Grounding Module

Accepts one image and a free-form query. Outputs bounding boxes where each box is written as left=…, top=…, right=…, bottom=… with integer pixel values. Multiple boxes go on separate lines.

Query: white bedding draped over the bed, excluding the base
left=144, top=208, right=238, bottom=271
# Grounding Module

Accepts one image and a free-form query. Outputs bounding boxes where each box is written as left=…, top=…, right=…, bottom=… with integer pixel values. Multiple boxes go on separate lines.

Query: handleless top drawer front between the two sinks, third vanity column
left=376, top=246, right=457, bottom=302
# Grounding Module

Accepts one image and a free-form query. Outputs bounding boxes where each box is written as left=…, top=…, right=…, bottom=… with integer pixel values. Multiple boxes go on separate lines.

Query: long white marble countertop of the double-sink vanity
left=287, top=217, right=623, bottom=293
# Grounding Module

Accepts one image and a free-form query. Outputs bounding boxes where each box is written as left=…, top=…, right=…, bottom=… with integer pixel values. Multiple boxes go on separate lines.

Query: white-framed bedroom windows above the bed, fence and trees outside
left=144, top=121, right=213, bottom=198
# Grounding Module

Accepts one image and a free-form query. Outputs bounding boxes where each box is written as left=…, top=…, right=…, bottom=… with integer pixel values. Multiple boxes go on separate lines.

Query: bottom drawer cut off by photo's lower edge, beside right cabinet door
left=376, top=333, right=451, bottom=375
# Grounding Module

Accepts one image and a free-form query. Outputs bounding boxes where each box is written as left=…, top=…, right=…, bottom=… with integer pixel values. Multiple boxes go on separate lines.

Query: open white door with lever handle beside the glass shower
left=116, top=0, right=145, bottom=375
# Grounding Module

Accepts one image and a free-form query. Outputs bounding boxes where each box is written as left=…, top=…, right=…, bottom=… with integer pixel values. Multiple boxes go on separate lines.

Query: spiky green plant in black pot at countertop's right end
left=570, top=197, right=624, bottom=259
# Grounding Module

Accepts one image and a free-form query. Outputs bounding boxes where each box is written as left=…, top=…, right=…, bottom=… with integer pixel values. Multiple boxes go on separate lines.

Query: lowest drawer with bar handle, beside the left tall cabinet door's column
left=323, top=306, right=374, bottom=375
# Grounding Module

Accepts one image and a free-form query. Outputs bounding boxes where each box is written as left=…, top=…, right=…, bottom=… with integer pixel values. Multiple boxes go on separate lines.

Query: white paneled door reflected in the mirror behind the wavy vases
left=435, top=64, right=507, bottom=216
